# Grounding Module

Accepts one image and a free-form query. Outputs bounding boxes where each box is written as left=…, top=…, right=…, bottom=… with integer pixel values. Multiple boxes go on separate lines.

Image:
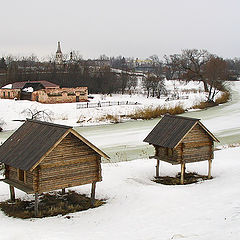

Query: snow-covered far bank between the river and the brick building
left=0, top=80, right=206, bottom=130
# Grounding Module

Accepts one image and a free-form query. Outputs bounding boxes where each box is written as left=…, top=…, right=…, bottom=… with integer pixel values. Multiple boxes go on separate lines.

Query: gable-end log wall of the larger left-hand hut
left=37, top=133, right=101, bottom=193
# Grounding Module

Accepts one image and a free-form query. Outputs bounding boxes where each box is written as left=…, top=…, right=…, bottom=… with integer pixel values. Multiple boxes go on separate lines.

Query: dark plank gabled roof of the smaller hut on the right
left=143, top=115, right=219, bottom=148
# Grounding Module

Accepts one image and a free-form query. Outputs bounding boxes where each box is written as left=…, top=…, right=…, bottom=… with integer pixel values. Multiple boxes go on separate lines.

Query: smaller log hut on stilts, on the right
left=144, top=115, right=219, bottom=184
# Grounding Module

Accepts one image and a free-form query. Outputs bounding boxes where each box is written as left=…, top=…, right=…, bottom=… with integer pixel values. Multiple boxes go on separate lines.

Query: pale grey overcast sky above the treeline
left=0, top=0, right=240, bottom=58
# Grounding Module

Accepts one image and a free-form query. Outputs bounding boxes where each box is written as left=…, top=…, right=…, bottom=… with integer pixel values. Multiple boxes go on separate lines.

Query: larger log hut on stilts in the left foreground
left=0, top=120, right=109, bottom=215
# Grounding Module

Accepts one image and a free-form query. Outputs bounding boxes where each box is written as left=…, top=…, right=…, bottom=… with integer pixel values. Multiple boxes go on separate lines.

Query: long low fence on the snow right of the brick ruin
left=77, top=101, right=139, bottom=109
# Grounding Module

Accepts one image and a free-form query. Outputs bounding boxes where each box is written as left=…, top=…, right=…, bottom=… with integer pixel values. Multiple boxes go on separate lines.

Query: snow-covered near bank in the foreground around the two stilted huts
left=0, top=148, right=240, bottom=240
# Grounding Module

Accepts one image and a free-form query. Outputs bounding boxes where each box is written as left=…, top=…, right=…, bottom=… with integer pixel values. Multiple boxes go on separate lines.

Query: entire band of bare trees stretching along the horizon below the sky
left=0, top=49, right=240, bottom=101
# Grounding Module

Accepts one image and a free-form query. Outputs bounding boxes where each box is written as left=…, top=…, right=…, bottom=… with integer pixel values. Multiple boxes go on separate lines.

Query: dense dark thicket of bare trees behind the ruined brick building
left=0, top=57, right=137, bottom=94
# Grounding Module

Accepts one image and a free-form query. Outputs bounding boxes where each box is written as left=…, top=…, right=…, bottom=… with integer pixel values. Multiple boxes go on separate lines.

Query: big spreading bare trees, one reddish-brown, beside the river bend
left=164, top=49, right=230, bottom=102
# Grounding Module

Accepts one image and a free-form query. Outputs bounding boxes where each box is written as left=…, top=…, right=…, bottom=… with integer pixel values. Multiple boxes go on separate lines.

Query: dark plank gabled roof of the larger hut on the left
left=0, top=120, right=109, bottom=170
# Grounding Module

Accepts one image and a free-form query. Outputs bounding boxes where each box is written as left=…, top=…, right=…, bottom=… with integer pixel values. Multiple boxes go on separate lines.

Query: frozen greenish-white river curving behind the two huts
left=0, top=82, right=240, bottom=162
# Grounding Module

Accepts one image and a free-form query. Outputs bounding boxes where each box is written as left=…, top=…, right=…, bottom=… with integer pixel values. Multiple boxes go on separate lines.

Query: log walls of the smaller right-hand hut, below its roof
left=154, top=124, right=213, bottom=164
